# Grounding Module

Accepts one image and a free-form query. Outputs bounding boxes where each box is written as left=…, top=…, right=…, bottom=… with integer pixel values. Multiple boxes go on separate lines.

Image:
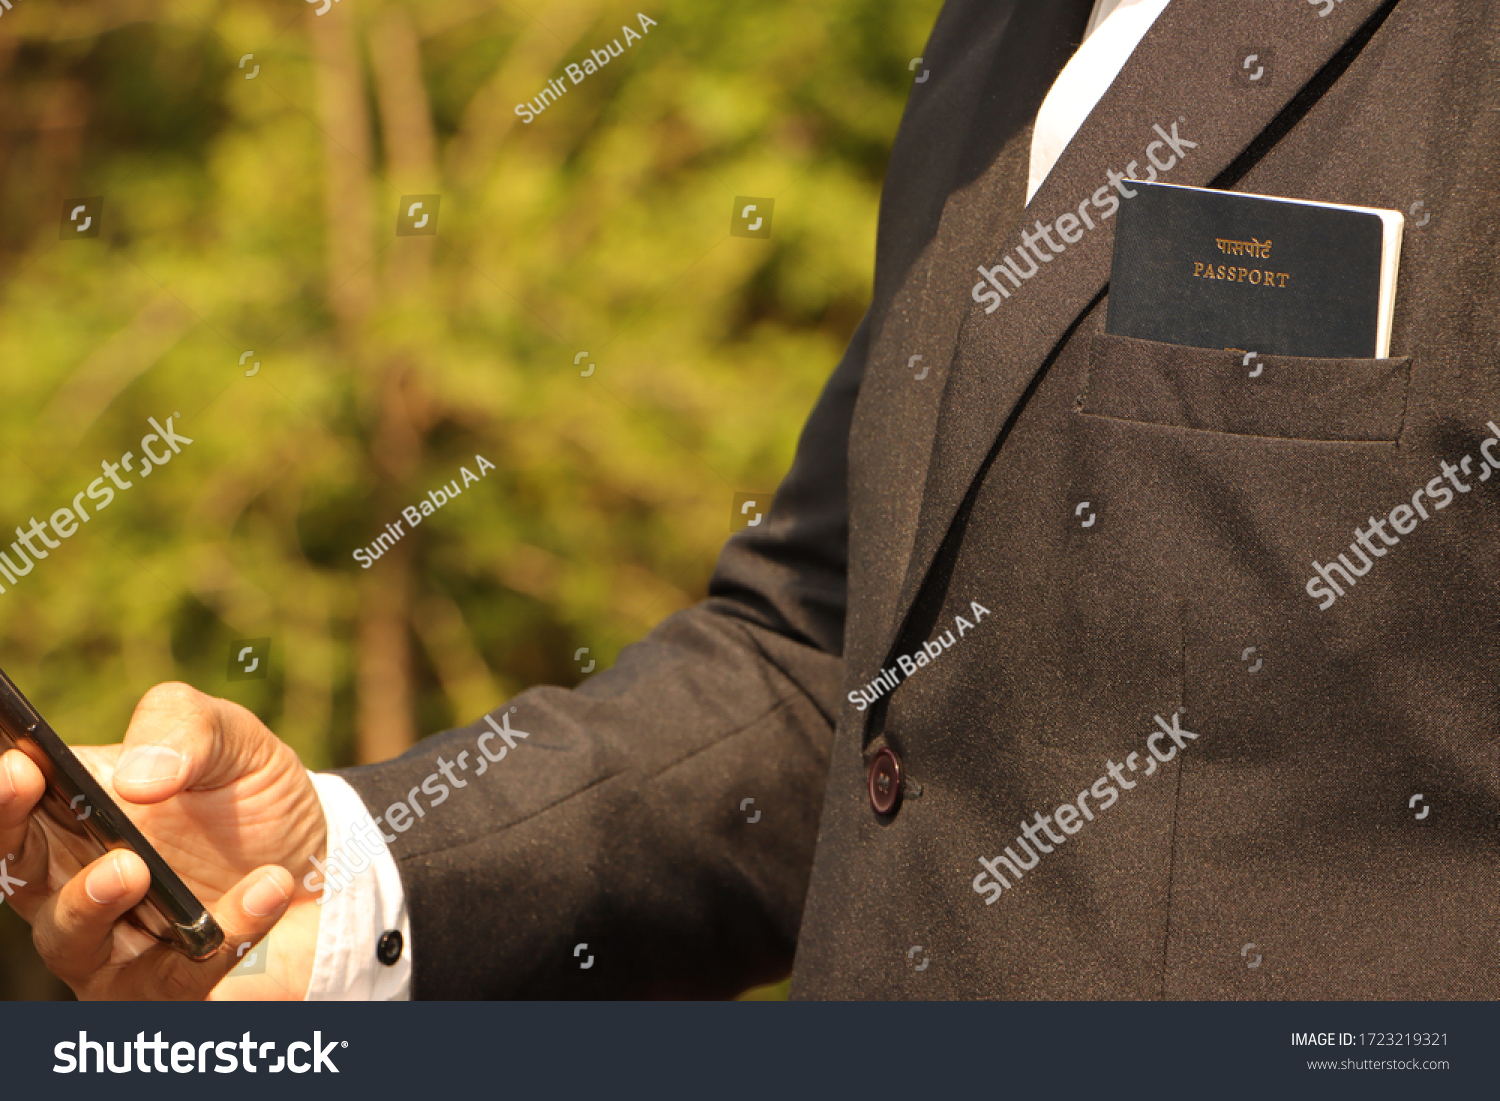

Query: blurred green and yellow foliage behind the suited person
left=0, top=0, right=939, bottom=998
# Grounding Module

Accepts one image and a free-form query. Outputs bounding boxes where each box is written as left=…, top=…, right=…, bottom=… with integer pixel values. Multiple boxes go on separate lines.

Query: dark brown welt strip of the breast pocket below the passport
left=1079, top=333, right=1412, bottom=443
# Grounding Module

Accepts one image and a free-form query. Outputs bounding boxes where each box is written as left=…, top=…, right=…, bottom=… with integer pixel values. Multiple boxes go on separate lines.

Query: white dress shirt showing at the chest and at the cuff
left=308, top=0, right=1169, bottom=1001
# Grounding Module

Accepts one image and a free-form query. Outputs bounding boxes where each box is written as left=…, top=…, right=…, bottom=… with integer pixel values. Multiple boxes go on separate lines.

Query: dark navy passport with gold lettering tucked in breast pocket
left=1104, top=180, right=1406, bottom=359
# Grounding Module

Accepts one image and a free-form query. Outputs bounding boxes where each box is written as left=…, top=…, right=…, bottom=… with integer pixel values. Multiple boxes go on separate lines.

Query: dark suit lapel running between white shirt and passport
left=882, top=0, right=1397, bottom=681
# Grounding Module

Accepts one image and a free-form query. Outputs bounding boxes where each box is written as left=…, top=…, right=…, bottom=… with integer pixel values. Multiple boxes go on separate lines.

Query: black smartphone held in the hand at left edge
left=0, top=669, right=224, bottom=960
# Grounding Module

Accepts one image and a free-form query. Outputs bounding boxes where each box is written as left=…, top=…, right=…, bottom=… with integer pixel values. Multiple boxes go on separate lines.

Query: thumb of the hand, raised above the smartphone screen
left=114, top=683, right=276, bottom=804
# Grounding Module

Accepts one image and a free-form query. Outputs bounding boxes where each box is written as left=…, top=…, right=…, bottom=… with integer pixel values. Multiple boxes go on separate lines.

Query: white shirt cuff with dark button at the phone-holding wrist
left=303, top=773, right=411, bottom=1002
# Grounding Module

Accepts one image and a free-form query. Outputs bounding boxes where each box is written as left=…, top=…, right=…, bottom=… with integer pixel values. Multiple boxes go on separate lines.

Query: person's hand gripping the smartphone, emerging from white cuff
left=0, top=684, right=327, bottom=1001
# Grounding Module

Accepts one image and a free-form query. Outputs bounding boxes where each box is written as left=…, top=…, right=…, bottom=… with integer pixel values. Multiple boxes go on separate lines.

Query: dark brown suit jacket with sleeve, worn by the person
left=347, top=0, right=1500, bottom=998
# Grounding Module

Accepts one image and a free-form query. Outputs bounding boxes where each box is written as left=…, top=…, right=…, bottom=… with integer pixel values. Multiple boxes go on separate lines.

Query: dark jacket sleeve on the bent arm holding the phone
left=341, top=318, right=869, bottom=999
